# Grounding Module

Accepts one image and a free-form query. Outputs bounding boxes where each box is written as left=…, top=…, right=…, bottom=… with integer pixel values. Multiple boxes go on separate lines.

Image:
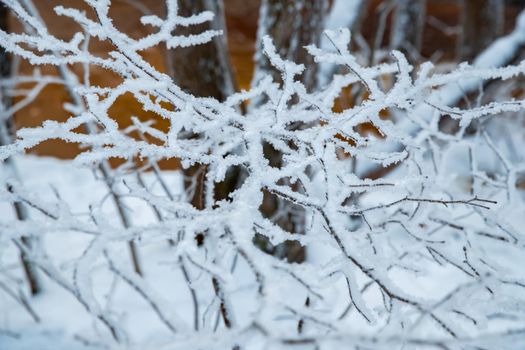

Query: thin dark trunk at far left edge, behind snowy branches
left=0, top=4, right=42, bottom=295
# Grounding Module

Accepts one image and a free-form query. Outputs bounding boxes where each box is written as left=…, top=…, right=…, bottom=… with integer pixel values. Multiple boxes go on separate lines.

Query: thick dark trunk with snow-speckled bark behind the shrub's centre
left=254, top=0, right=328, bottom=262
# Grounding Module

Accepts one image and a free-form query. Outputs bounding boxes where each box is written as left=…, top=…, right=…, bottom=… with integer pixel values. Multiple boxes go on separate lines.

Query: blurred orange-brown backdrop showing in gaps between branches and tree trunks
left=8, top=0, right=525, bottom=161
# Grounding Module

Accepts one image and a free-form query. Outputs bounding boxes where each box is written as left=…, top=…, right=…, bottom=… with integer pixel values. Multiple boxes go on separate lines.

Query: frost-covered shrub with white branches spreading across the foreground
left=0, top=0, right=525, bottom=349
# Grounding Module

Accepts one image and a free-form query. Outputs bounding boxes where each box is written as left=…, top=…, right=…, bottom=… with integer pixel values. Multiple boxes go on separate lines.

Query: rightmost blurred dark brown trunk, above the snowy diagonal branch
left=458, top=0, right=505, bottom=61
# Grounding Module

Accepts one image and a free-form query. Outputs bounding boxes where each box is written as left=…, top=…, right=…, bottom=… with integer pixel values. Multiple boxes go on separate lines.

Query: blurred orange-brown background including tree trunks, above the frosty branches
left=6, top=0, right=525, bottom=161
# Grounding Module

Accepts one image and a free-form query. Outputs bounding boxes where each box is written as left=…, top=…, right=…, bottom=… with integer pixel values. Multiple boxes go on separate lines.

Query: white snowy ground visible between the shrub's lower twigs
left=0, top=156, right=524, bottom=350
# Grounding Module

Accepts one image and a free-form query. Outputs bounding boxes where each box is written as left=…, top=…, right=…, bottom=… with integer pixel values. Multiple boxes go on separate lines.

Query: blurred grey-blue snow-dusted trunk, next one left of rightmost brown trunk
left=390, top=0, right=426, bottom=61
